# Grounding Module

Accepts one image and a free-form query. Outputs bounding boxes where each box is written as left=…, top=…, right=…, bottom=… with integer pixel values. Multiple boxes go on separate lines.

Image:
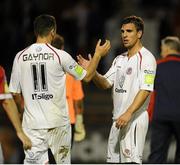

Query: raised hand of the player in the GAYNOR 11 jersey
left=95, top=39, right=111, bottom=57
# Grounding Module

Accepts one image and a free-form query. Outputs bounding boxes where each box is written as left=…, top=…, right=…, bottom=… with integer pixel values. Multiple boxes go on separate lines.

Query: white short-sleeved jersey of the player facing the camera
left=104, top=47, right=156, bottom=119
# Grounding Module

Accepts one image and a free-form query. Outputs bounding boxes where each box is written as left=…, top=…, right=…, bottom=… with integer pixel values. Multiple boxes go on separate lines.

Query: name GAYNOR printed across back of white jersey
left=23, top=53, right=54, bottom=61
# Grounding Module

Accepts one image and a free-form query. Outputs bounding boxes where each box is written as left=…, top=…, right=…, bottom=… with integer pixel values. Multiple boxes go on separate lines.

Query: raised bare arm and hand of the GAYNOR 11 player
left=83, top=40, right=111, bottom=82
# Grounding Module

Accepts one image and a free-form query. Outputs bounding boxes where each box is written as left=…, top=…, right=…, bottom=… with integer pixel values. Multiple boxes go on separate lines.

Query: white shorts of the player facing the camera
left=107, top=111, right=149, bottom=163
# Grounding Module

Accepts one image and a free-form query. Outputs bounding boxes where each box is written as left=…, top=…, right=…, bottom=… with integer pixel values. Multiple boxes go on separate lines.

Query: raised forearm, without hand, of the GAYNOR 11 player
left=83, top=53, right=101, bottom=82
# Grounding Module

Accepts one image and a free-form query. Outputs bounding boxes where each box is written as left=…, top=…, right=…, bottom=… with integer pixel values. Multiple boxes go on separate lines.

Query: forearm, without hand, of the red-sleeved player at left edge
left=2, top=99, right=22, bottom=133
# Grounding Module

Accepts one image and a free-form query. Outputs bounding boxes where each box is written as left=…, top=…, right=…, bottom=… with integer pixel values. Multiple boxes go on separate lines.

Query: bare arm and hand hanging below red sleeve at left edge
left=2, top=96, right=32, bottom=149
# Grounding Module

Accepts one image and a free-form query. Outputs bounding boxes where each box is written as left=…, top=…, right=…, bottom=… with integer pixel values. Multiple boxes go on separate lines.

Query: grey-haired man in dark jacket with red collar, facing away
left=148, top=36, right=180, bottom=164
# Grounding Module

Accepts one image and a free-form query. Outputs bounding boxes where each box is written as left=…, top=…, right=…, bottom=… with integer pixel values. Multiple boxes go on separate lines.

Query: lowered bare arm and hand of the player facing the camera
left=116, top=90, right=150, bottom=128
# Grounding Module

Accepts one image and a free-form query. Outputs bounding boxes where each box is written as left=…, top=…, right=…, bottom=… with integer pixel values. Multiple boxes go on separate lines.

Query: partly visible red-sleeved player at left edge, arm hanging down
left=0, top=66, right=32, bottom=163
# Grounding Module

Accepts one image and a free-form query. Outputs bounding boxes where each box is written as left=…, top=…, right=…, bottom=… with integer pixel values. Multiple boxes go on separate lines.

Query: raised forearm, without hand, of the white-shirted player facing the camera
left=93, top=71, right=111, bottom=89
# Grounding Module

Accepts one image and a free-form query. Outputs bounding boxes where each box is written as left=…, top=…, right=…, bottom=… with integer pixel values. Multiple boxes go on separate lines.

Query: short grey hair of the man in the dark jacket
left=161, top=36, right=180, bottom=52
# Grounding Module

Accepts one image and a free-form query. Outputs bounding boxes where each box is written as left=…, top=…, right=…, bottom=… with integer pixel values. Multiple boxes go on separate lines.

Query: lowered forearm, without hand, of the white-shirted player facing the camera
left=126, top=90, right=150, bottom=114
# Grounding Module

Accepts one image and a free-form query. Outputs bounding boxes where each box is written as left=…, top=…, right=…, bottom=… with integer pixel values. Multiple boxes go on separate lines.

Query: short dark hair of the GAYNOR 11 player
left=34, top=14, right=56, bottom=37
